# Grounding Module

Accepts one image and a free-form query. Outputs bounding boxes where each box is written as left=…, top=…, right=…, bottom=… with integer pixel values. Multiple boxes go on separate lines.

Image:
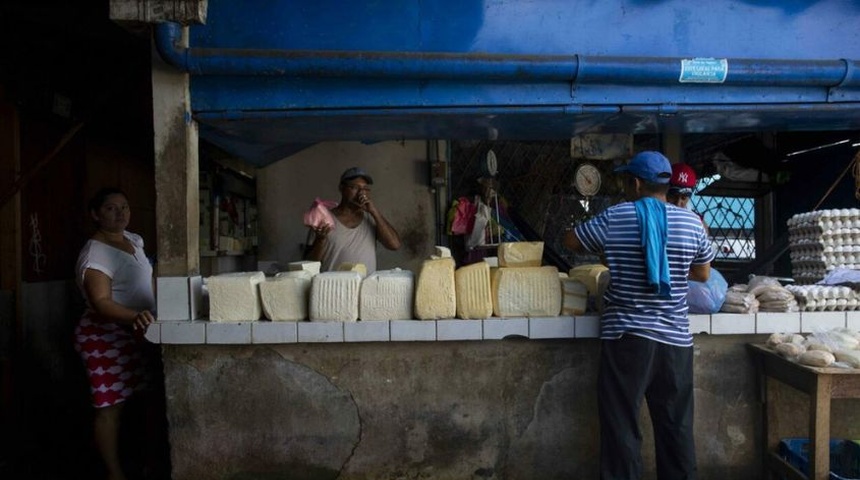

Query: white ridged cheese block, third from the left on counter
left=308, top=272, right=361, bottom=322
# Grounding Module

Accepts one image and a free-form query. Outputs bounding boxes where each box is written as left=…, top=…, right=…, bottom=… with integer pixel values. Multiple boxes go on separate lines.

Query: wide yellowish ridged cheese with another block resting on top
left=492, top=265, right=561, bottom=317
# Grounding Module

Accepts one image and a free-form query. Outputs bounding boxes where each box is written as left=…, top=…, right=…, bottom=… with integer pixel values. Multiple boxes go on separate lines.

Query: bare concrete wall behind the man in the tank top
left=257, top=141, right=435, bottom=271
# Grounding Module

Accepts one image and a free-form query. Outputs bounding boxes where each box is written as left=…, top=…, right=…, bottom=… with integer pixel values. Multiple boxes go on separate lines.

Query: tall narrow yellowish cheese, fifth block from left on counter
left=415, top=257, right=457, bottom=320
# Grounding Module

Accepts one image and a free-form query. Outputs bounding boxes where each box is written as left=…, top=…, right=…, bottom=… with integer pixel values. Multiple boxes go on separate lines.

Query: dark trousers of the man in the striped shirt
left=597, top=335, right=696, bottom=480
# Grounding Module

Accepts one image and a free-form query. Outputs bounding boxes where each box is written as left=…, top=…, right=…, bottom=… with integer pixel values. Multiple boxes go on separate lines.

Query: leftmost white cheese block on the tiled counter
left=206, top=272, right=266, bottom=322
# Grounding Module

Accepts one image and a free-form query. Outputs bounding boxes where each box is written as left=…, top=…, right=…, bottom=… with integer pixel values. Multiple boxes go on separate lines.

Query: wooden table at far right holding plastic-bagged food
left=747, top=344, right=860, bottom=480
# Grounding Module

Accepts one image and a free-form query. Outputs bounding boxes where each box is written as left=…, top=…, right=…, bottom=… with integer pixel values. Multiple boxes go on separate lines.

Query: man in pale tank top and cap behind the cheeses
left=308, top=167, right=400, bottom=273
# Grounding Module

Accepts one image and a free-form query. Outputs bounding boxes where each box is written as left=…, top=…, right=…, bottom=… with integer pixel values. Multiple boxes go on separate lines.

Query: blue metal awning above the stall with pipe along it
left=155, top=0, right=860, bottom=166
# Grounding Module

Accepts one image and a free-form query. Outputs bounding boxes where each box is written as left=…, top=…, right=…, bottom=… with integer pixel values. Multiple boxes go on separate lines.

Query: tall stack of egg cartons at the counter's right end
left=788, top=208, right=860, bottom=285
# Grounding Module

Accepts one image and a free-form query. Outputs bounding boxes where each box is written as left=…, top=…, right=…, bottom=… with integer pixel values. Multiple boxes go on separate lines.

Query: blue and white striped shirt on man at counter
left=576, top=202, right=715, bottom=347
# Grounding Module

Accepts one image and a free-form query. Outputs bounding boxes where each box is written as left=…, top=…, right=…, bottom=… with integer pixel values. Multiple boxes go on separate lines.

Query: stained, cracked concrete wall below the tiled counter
left=163, top=335, right=860, bottom=480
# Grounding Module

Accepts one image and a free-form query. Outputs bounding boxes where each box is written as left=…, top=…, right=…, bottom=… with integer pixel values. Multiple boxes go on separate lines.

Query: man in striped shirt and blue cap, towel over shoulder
left=565, top=151, right=714, bottom=480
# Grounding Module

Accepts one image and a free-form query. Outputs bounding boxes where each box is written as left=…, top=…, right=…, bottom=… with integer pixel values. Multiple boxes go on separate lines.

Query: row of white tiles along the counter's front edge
left=146, top=311, right=860, bottom=345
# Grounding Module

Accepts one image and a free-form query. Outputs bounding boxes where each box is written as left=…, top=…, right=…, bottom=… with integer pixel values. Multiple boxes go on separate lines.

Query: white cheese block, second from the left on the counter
left=260, top=270, right=312, bottom=322
